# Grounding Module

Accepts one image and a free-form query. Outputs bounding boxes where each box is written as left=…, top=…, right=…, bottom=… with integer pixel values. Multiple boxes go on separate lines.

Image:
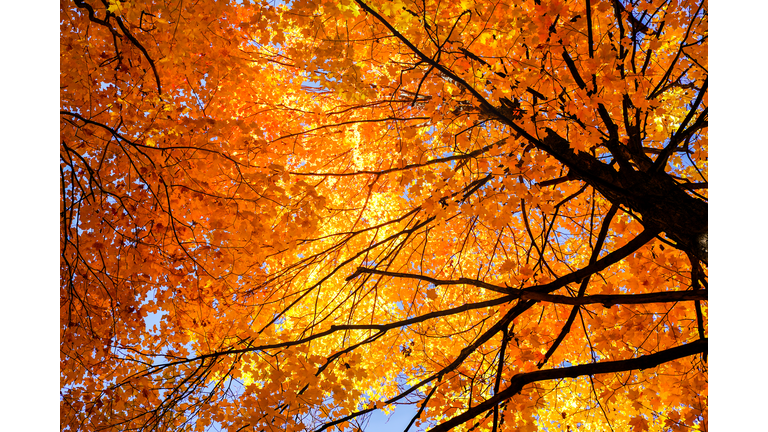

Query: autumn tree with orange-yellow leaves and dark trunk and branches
left=60, top=0, right=708, bottom=432
